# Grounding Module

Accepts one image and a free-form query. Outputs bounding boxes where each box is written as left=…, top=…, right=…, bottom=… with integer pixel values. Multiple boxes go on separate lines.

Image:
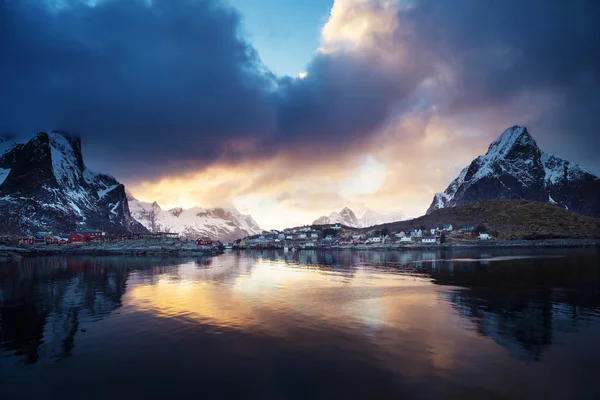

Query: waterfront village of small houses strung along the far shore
left=0, top=224, right=492, bottom=250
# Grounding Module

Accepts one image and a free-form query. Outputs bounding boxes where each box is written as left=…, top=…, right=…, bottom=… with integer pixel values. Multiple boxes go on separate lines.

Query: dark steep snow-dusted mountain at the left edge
left=0, top=131, right=146, bottom=234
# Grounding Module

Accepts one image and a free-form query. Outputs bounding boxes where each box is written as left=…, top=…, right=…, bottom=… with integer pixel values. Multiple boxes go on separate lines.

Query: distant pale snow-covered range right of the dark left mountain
left=128, top=195, right=262, bottom=242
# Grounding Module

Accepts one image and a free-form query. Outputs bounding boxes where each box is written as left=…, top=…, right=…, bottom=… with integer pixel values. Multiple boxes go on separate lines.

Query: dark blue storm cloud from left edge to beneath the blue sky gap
left=0, top=0, right=422, bottom=177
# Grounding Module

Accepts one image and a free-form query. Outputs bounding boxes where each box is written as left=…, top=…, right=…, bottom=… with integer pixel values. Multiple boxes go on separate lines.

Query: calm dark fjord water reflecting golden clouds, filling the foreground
left=0, top=249, right=600, bottom=399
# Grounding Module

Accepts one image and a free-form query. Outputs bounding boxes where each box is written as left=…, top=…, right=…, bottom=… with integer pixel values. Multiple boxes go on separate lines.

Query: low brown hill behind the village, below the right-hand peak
left=367, top=200, right=600, bottom=239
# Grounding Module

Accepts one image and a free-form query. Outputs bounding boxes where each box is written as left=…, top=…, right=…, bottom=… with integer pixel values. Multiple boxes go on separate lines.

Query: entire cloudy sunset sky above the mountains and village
left=0, top=0, right=600, bottom=228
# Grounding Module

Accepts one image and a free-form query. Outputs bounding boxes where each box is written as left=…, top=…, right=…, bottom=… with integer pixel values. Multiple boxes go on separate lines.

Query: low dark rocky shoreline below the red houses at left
left=0, top=240, right=223, bottom=261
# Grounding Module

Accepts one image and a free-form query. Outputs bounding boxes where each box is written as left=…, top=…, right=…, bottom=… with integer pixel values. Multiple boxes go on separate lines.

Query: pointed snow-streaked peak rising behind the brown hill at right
left=427, top=126, right=600, bottom=217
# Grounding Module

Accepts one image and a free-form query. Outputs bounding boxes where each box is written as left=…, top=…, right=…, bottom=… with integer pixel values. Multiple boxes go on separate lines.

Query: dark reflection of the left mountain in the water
left=0, top=257, right=190, bottom=364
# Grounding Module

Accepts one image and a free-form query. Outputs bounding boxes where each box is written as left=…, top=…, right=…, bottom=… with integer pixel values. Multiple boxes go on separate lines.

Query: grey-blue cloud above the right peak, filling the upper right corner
left=399, top=0, right=600, bottom=168
